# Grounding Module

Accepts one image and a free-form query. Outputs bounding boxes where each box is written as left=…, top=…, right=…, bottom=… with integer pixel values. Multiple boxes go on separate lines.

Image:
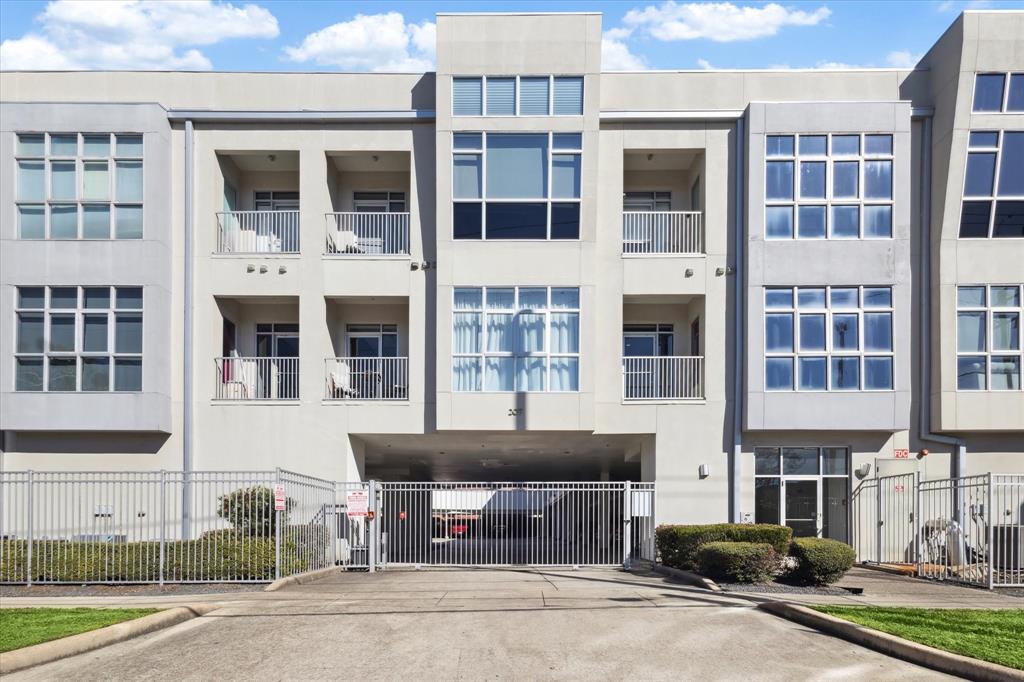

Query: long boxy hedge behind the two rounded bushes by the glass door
left=655, top=523, right=793, bottom=570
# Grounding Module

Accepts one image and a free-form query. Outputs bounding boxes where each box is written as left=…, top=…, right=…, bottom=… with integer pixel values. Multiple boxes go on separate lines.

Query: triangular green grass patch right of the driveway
left=811, top=606, right=1024, bottom=670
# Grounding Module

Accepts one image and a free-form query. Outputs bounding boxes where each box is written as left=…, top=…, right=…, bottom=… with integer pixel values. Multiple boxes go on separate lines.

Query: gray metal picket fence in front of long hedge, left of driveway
left=0, top=469, right=335, bottom=584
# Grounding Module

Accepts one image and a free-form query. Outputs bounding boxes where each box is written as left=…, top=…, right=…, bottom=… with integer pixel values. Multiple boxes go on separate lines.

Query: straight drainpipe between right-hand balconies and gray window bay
left=729, top=117, right=746, bottom=523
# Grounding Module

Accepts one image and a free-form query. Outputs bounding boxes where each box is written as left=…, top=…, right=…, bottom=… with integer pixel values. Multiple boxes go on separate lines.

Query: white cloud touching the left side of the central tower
left=285, top=12, right=436, bottom=72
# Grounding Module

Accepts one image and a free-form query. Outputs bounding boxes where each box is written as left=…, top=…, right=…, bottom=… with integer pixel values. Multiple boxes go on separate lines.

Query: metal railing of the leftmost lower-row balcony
left=213, top=357, right=299, bottom=400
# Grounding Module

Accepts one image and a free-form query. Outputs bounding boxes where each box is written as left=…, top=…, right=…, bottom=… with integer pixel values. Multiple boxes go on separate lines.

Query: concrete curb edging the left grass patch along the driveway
left=0, top=604, right=220, bottom=675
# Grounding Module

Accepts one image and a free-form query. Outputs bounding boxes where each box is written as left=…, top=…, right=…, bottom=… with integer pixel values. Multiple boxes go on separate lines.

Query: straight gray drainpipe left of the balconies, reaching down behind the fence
left=181, top=119, right=196, bottom=540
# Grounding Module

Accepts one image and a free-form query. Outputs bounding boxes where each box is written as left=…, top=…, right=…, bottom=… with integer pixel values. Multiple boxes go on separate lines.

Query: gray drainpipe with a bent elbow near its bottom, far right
left=913, top=112, right=967, bottom=475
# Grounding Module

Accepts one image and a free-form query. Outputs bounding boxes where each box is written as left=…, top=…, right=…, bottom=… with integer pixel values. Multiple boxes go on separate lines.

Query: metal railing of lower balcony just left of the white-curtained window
left=324, top=357, right=409, bottom=400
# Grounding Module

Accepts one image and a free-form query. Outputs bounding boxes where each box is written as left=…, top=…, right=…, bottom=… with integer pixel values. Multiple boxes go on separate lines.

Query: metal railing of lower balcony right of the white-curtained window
left=623, top=355, right=705, bottom=400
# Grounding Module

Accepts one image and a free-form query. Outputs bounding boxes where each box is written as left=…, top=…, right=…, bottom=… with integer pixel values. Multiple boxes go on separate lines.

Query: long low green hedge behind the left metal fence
left=0, top=534, right=303, bottom=583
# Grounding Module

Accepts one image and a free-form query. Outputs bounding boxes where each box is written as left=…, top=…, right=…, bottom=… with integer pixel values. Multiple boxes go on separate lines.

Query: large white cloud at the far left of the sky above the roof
left=0, top=0, right=280, bottom=71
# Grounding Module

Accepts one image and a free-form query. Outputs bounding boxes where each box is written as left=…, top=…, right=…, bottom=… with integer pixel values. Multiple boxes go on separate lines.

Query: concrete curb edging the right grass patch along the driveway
left=757, top=601, right=1024, bottom=682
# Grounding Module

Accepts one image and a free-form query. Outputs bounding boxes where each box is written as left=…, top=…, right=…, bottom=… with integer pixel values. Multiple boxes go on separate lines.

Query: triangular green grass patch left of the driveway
left=0, top=608, right=160, bottom=653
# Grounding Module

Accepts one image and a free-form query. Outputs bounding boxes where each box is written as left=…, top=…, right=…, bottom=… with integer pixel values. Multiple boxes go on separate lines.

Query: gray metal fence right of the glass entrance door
left=853, top=473, right=1024, bottom=588
